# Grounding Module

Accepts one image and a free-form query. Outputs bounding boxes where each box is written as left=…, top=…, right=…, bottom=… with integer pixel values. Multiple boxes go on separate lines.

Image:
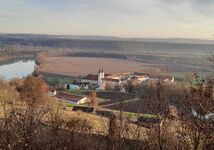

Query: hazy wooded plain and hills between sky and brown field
left=0, top=34, right=214, bottom=72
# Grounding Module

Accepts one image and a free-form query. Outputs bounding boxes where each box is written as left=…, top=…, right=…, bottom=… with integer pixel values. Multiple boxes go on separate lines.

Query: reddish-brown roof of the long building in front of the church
left=56, top=92, right=84, bottom=102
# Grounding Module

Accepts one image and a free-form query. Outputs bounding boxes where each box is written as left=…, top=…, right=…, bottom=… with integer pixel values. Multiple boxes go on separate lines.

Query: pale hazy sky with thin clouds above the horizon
left=0, top=0, right=214, bottom=39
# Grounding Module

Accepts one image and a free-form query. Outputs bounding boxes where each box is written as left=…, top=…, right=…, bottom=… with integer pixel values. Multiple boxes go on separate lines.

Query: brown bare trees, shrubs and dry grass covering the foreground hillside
left=0, top=70, right=214, bottom=150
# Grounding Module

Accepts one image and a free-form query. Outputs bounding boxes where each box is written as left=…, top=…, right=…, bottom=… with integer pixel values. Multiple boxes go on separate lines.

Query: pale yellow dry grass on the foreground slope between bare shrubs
left=0, top=103, right=147, bottom=139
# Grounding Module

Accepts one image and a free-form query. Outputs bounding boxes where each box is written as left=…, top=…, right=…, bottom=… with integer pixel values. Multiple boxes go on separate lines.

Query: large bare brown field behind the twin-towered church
left=39, top=57, right=161, bottom=76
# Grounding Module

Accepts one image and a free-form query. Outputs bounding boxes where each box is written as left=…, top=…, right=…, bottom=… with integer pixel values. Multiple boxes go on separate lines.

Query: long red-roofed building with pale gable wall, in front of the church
left=56, top=92, right=91, bottom=104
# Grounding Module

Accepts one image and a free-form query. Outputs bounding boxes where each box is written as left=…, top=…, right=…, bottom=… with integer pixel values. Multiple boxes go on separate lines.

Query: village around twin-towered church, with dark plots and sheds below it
left=44, top=68, right=175, bottom=126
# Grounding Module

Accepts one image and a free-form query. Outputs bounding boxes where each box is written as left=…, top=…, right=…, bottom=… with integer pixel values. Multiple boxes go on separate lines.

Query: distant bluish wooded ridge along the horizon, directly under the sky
left=0, top=34, right=214, bottom=55
